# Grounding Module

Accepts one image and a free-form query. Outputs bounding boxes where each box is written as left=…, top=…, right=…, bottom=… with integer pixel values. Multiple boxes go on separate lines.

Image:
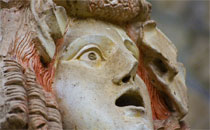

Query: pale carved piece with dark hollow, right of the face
left=139, top=21, right=188, bottom=118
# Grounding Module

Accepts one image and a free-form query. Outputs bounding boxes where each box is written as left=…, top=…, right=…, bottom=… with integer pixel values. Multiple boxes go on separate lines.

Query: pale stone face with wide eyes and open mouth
left=53, top=20, right=152, bottom=130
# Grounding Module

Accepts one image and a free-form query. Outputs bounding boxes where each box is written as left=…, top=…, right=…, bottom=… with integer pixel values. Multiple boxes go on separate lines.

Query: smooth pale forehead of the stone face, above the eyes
left=61, top=19, right=135, bottom=60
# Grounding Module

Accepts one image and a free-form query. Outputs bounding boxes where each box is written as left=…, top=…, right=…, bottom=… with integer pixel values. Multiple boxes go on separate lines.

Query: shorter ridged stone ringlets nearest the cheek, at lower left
left=26, top=71, right=62, bottom=130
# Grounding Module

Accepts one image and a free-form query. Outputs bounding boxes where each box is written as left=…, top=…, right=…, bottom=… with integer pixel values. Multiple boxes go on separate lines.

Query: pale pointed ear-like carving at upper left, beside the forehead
left=31, top=0, right=67, bottom=60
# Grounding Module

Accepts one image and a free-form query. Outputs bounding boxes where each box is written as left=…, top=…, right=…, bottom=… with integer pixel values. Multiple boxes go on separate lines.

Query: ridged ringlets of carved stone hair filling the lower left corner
left=0, top=57, right=62, bottom=130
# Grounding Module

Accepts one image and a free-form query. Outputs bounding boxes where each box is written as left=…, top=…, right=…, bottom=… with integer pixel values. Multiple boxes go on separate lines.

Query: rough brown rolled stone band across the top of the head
left=54, top=0, right=151, bottom=23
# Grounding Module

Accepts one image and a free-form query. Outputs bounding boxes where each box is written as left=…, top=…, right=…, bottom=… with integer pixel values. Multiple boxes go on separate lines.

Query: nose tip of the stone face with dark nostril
left=112, top=60, right=138, bottom=85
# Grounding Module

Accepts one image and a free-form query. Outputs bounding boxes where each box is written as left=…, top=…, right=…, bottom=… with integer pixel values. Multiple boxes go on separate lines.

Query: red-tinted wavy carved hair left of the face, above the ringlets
left=11, top=32, right=55, bottom=92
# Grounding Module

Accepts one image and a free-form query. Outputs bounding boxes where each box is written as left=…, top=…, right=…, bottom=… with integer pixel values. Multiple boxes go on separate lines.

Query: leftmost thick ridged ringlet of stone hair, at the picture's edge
left=0, top=57, right=28, bottom=129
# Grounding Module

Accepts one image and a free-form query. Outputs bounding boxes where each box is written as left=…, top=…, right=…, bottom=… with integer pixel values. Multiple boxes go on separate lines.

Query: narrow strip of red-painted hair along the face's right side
left=127, top=25, right=171, bottom=120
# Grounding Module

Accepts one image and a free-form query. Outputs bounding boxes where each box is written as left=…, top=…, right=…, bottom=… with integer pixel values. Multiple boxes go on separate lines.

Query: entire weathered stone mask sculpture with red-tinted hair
left=0, top=0, right=188, bottom=130
